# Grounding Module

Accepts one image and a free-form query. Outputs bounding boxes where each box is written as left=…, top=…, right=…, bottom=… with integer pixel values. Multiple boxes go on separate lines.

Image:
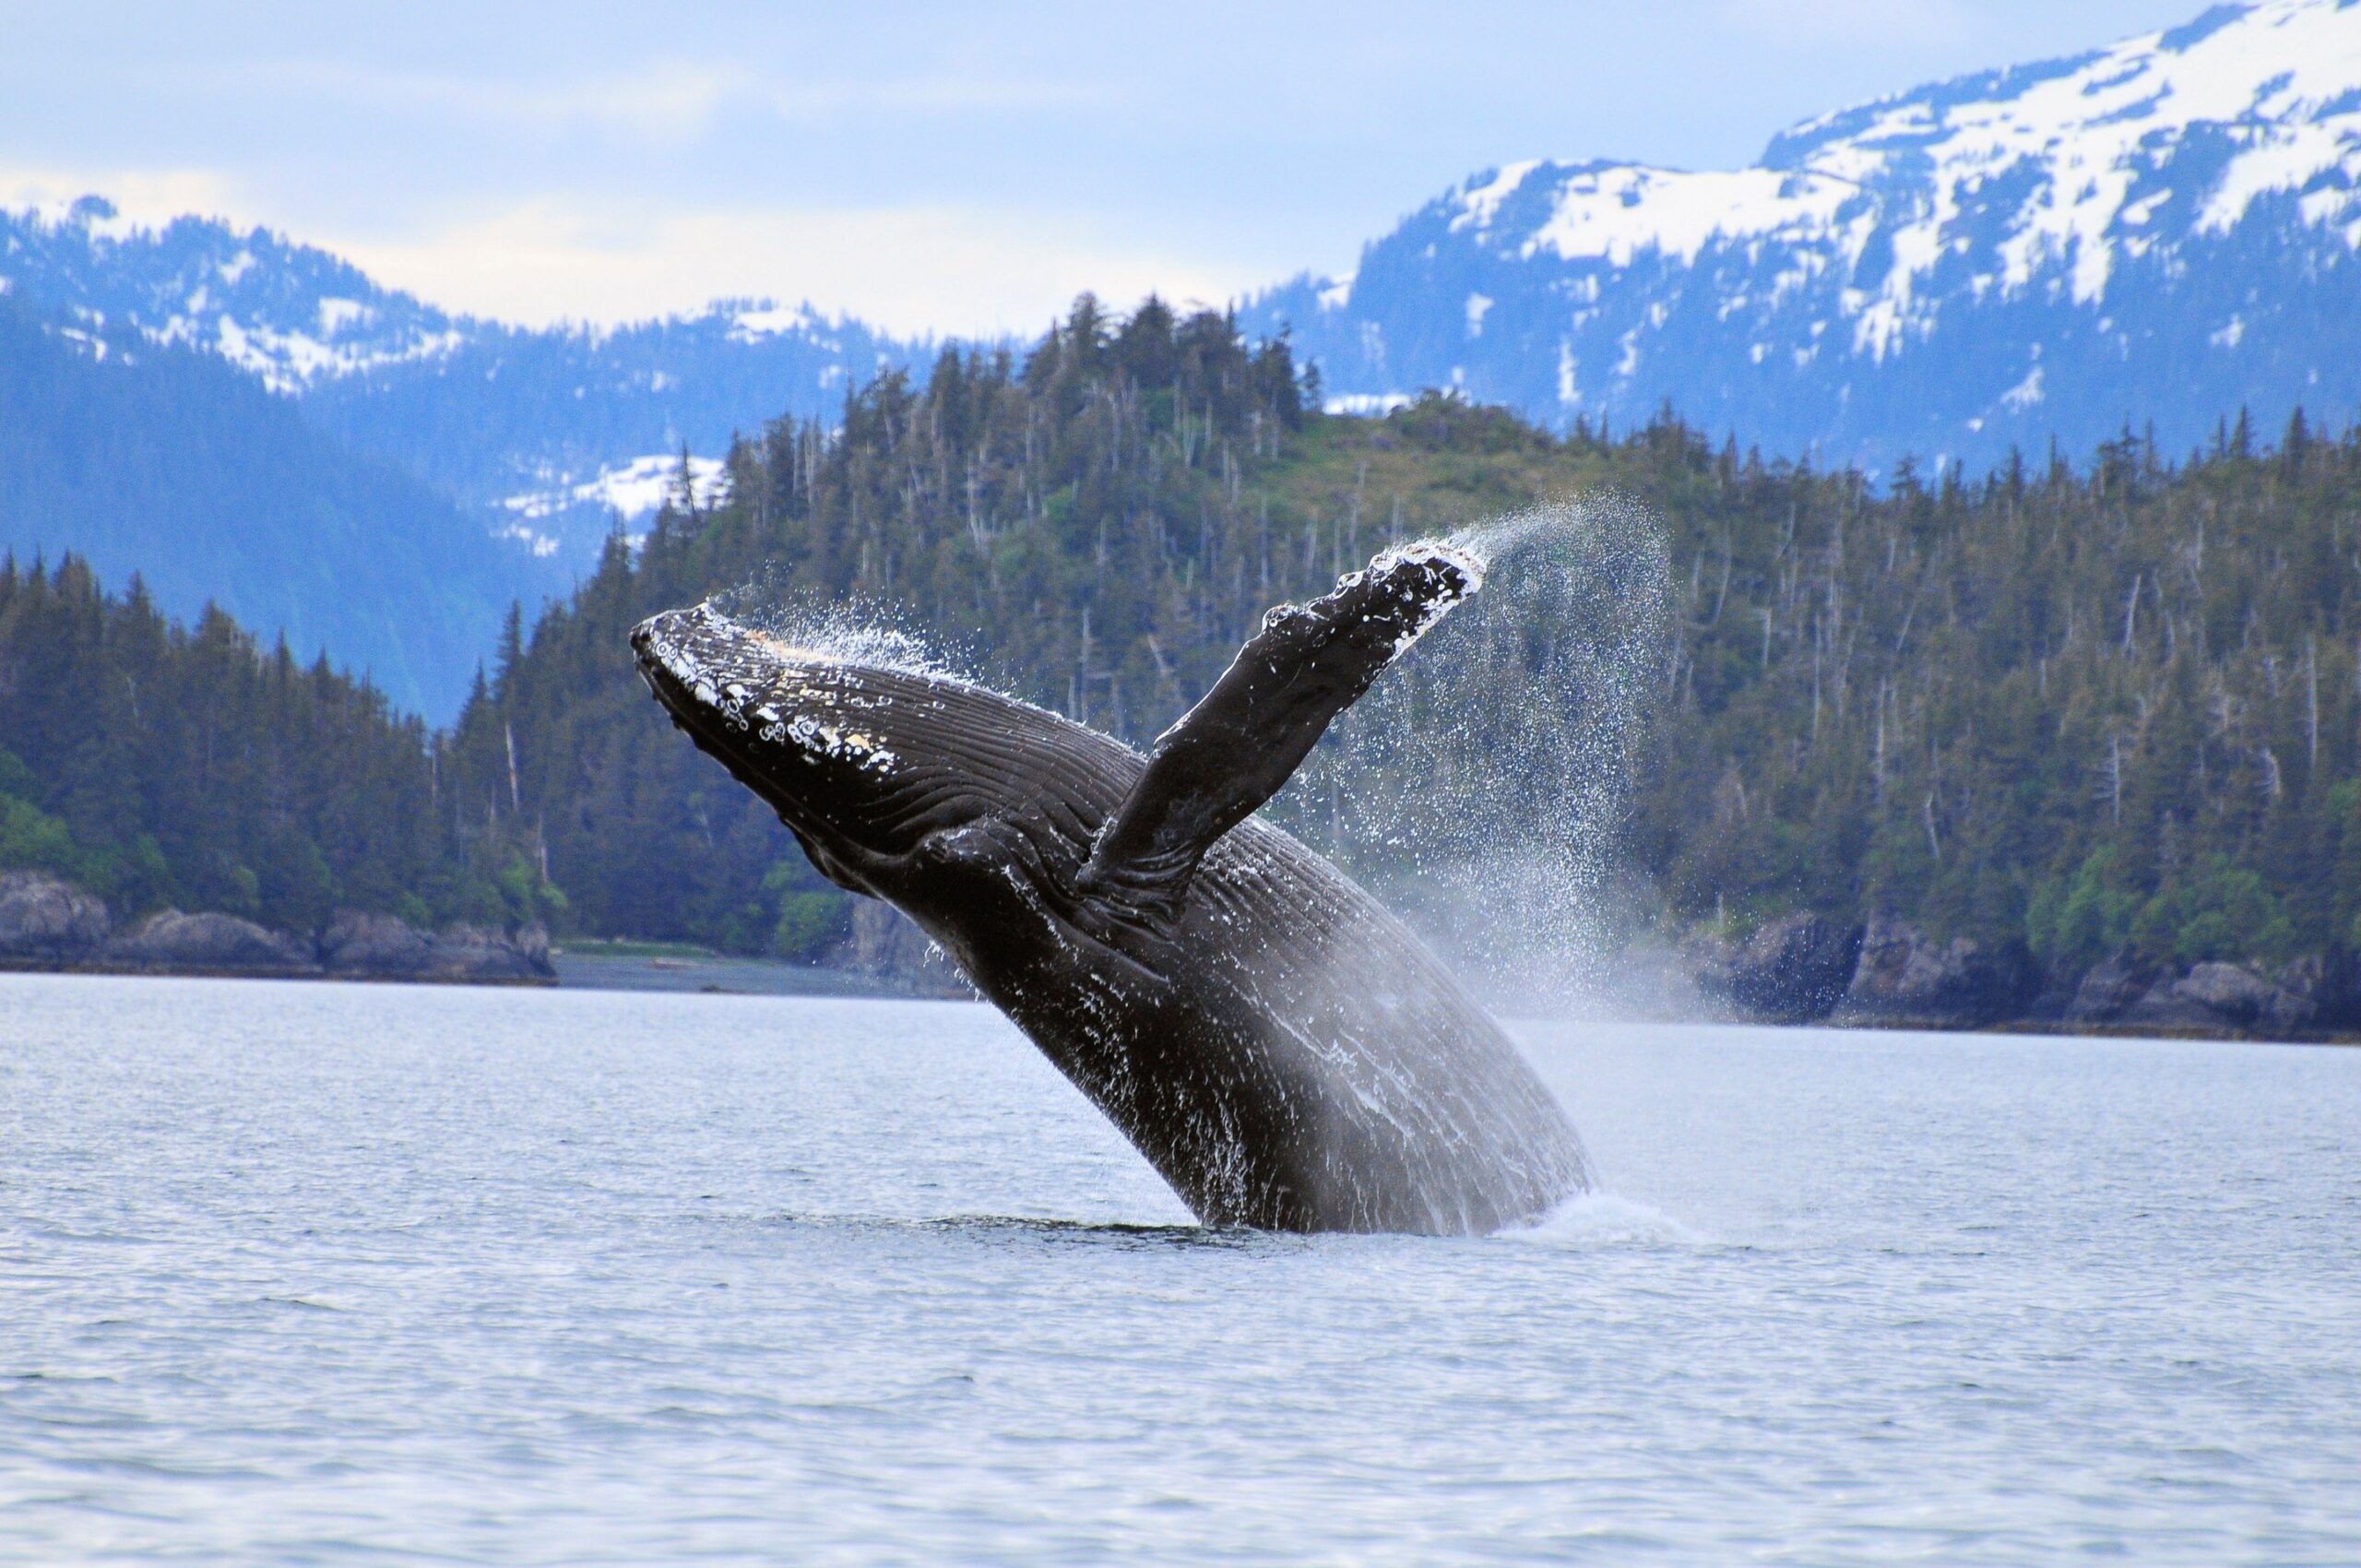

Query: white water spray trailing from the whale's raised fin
left=1291, top=493, right=1669, bottom=1013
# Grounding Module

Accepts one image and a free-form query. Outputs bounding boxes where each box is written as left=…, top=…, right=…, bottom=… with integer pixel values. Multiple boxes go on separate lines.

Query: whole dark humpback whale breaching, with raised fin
left=631, top=540, right=1589, bottom=1235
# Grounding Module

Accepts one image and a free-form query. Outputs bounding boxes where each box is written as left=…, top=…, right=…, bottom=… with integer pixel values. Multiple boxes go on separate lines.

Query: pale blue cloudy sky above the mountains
left=0, top=0, right=2205, bottom=333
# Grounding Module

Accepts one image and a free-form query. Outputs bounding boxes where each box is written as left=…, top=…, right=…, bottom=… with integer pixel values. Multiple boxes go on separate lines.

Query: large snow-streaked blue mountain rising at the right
left=1247, top=0, right=2361, bottom=468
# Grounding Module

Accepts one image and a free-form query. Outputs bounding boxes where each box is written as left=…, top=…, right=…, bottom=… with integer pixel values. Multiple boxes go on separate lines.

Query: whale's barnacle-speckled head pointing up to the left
left=631, top=604, right=1138, bottom=902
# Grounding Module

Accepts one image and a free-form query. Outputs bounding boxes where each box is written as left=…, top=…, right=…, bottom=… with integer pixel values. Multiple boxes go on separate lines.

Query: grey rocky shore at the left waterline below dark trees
left=0, top=872, right=557, bottom=985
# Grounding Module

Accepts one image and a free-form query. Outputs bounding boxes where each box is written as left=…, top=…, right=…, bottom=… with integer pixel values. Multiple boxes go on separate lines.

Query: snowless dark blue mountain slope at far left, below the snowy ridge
left=0, top=295, right=538, bottom=720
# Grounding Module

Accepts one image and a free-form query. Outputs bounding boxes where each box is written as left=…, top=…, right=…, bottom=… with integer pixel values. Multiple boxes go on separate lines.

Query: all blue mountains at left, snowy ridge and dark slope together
left=0, top=196, right=935, bottom=722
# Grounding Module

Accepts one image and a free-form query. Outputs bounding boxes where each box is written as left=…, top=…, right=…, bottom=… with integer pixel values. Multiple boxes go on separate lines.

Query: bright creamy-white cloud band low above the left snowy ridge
left=335, top=198, right=1264, bottom=333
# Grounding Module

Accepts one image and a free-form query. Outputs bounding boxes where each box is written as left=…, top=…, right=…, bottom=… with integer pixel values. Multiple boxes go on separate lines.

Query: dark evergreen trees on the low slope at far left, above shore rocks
left=0, top=557, right=560, bottom=931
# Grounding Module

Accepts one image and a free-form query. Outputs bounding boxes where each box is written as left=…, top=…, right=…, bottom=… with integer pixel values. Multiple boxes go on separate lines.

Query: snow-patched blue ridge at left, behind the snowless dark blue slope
left=0, top=196, right=928, bottom=564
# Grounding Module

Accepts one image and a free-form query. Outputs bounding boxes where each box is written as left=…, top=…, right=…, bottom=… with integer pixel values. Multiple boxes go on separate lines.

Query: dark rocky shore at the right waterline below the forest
left=1683, top=914, right=2361, bottom=1041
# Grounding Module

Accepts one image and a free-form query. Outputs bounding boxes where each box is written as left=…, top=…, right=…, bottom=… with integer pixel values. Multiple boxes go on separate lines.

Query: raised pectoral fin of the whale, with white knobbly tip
left=1079, top=540, right=1483, bottom=919
